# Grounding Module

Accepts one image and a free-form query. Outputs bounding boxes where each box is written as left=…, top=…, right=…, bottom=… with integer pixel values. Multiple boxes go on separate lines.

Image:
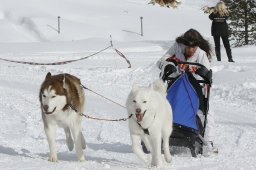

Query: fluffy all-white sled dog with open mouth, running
left=126, top=80, right=172, bottom=167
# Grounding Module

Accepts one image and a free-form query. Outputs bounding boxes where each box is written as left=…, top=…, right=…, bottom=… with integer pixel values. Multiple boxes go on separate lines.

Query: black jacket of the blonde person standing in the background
left=209, top=13, right=228, bottom=36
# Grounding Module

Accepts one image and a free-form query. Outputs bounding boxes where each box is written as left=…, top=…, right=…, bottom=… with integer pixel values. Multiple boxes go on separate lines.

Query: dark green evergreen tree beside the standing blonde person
left=224, top=0, right=256, bottom=47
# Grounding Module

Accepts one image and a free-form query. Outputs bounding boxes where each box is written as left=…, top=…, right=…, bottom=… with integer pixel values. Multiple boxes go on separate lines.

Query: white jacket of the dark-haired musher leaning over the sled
left=157, top=42, right=210, bottom=70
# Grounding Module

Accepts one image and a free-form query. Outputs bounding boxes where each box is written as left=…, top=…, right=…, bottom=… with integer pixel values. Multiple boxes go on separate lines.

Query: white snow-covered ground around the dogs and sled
left=0, top=0, right=256, bottom=170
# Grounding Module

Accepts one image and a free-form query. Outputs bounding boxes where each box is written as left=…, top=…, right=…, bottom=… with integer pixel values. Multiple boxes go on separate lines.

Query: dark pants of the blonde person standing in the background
left=213, top=35, right=232, bottom=61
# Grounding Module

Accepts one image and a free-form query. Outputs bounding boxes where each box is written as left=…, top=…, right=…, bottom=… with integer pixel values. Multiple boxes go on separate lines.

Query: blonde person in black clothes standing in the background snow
left=209, top=1, right=234, bottom=62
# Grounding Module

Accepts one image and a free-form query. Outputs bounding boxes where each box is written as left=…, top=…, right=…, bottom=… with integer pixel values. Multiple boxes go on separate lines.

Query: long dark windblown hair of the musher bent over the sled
left=176, top=29, right=211, bottom=60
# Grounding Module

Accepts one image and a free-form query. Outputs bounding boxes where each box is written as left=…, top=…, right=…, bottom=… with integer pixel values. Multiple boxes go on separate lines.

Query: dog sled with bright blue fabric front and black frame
left=142, top=61, right=212, bottom=157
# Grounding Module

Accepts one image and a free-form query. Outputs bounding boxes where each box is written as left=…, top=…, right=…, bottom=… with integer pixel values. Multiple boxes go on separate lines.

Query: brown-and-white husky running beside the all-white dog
left=39, top=73, right=86, bottom=162
